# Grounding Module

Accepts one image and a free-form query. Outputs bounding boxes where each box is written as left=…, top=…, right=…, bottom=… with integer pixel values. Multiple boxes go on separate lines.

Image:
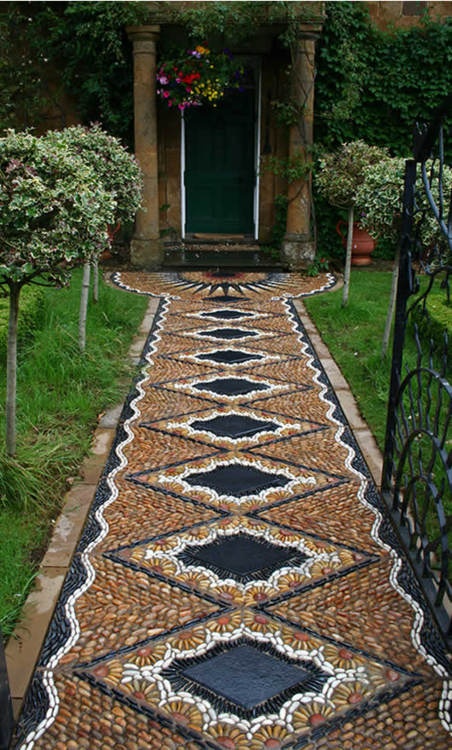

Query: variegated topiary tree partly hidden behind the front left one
left=46, top=124, right=143, bottom=351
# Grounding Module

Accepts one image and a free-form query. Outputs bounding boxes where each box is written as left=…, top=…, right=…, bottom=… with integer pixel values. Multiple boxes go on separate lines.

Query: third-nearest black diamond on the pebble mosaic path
left=185, top=464, right=289, bottom=497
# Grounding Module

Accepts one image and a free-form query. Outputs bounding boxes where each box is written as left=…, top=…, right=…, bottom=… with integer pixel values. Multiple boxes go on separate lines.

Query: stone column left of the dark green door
left=127, top=25, right=163, bottom=269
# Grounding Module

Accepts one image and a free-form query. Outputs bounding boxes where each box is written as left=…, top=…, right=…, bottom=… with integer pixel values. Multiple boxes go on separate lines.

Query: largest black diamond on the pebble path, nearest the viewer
left=162, top=639, right=328, bottom=719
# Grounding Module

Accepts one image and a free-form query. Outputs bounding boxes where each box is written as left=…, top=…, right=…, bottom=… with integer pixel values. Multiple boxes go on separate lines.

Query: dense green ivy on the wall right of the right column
left=316, top=2, right=452, bottom=156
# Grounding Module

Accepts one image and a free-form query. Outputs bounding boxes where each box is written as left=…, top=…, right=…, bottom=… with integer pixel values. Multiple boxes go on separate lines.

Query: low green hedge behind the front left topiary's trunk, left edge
left=0, top=286, right=44, bottom=366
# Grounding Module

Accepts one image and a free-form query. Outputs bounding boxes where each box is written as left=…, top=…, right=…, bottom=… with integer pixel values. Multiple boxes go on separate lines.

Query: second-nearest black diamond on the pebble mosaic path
left=178, top=533, right=307, bottom=583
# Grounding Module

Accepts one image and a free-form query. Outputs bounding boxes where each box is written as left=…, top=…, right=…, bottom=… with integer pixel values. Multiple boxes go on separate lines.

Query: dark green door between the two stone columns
left=185, top=91, right=255, bottom=234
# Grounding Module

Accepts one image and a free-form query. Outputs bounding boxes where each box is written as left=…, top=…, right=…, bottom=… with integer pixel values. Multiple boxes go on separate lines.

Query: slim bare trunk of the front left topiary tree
left=6, top=283, right=21, bottom=456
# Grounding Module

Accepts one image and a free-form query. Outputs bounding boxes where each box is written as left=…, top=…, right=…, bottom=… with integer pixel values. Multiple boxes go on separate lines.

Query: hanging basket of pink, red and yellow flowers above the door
left=157, top=45, right=245, bottom=111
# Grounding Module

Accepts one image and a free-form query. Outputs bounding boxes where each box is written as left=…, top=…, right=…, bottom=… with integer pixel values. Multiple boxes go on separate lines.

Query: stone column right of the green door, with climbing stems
left=282, top=24, right=318, bottom=270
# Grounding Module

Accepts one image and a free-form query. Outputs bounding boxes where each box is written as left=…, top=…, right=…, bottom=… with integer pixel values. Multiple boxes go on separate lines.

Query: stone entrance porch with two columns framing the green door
left=128, top=3, right=323, bottom=269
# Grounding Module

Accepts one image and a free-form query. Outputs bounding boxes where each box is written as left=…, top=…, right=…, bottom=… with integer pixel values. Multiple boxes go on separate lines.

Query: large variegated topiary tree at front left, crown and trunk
left=0, top=130, right=115, bottom=456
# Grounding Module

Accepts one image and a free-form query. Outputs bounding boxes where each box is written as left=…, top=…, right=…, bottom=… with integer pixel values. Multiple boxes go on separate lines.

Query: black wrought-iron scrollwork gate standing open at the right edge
left=382, top=96, right=452, bottom=646
